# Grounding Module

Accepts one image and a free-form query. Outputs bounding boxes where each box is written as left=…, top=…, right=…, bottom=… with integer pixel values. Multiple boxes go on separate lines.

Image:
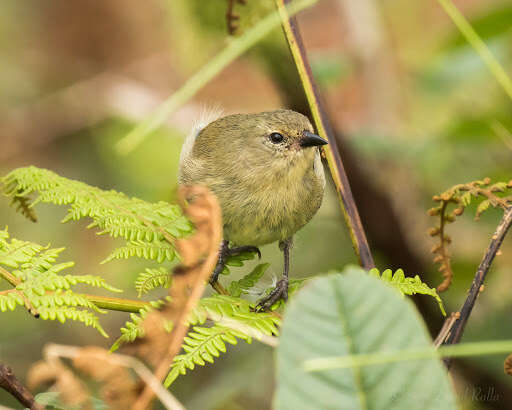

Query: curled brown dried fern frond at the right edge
left=428, top=178, right=512, bottom=292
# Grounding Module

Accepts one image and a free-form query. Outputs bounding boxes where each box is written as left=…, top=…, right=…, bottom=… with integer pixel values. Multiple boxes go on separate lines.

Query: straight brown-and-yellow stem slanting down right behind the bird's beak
left=275, top=0, right=375, bottom=270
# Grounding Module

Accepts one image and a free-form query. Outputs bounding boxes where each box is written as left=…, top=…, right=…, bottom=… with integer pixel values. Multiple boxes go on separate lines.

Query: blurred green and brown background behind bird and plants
left=0, top=0, right=512, bottom=410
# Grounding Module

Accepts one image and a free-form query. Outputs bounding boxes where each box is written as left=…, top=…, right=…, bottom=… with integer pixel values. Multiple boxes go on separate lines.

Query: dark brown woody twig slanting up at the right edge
left=436, top=207, right=512, bottom=367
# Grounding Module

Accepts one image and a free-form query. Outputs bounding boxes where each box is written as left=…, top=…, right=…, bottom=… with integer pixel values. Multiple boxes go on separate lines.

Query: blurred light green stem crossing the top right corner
left=437, top=0, right=512, bottom=99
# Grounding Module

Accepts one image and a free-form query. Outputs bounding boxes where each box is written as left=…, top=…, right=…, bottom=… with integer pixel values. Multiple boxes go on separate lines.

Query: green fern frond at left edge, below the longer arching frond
left=0, top=229, right=120, bottom=337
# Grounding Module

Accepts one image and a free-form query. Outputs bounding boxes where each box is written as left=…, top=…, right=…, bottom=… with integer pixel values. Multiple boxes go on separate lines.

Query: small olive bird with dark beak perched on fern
left=179, top=110, right=327, bottom=310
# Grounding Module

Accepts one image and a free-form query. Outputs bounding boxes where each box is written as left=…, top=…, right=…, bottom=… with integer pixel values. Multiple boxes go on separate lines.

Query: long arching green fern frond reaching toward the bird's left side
left=2, top=166, right=192, bottom=262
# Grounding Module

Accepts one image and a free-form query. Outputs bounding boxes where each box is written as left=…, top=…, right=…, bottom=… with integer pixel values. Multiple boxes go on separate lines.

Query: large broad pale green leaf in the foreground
left=274, top=267, right=456, bottom=410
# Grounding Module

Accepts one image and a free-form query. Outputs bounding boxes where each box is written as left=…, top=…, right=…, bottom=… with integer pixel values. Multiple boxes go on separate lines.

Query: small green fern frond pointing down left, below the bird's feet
left=164, top=324, right=251, bottom=387
